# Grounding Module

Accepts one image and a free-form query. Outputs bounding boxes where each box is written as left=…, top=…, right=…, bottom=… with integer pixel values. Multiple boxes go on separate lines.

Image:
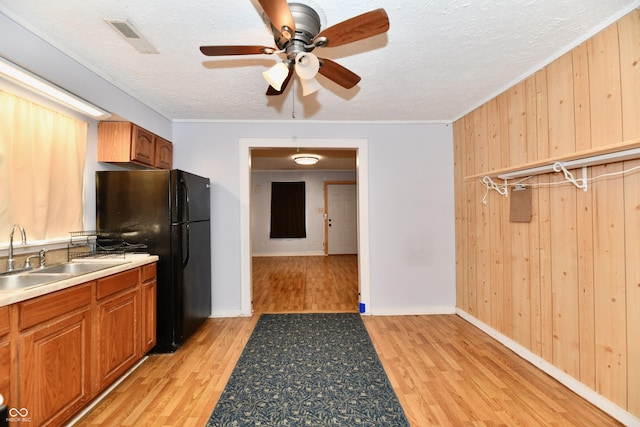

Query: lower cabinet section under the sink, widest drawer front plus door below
left=16, top=284, right=92, bottom=426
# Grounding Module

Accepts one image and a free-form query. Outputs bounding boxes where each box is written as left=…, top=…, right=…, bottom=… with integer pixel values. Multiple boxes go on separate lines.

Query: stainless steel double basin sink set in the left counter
left=0, top=261, right=127, bottom=292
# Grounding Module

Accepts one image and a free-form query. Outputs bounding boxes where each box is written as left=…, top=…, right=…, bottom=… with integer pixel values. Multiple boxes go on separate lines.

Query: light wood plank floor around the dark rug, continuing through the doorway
left=77, top=256, right=620, bottom=427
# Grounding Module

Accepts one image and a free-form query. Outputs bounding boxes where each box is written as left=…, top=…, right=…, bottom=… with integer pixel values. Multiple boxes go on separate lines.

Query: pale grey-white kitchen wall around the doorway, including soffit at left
left=0, top=13, right=455, bottom=315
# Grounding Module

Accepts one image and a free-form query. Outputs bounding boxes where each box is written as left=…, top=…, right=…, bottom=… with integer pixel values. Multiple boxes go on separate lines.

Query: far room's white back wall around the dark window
left=251, top=171, right=356, bottom=256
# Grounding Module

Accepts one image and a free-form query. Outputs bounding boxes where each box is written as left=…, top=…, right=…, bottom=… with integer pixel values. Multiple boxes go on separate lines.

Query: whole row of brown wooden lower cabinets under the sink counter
left=0, top=263, right=156, bottom=426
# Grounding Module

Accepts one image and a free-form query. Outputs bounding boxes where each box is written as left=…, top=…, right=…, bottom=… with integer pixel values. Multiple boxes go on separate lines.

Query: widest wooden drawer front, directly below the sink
left=18, top=282, right=92, bottom=330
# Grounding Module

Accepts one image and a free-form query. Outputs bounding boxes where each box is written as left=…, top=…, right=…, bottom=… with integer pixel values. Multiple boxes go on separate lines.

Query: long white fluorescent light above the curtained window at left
left=0, top=57, right=111, bottom=119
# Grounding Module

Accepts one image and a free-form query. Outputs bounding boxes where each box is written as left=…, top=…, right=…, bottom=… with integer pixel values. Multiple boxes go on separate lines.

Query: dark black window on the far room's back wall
left=269, top=182, right=307, bottom=239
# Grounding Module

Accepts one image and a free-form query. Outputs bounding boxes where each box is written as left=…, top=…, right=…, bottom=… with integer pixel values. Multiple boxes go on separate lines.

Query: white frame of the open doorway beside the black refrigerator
left=238, top=137, right=371, bottom=316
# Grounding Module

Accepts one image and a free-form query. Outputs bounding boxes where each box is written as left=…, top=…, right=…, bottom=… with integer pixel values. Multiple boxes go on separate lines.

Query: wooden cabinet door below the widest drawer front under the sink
left=18, top=307, right=91, bottom=426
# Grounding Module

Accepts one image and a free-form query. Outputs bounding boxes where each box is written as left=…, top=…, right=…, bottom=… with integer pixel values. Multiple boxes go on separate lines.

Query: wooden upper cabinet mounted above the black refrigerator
left=98, top=122, right=173, bottom=169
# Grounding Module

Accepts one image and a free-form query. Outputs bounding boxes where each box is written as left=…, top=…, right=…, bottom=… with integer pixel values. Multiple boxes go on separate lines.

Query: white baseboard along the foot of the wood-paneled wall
left=456, top=308, right=640, bottom=427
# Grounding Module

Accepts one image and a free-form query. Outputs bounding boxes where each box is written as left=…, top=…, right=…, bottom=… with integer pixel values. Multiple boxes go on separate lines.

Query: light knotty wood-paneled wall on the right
left=454, top=10, right=640, bottom=416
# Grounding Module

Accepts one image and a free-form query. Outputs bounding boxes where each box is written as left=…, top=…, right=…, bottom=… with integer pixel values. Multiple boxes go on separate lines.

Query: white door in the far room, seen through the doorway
left=327, top=184, right=358, bottom=255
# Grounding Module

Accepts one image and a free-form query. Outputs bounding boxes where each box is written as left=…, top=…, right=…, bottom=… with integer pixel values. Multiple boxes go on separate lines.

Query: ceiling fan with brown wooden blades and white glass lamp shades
left=200, top=0, right=389, bottom=96
